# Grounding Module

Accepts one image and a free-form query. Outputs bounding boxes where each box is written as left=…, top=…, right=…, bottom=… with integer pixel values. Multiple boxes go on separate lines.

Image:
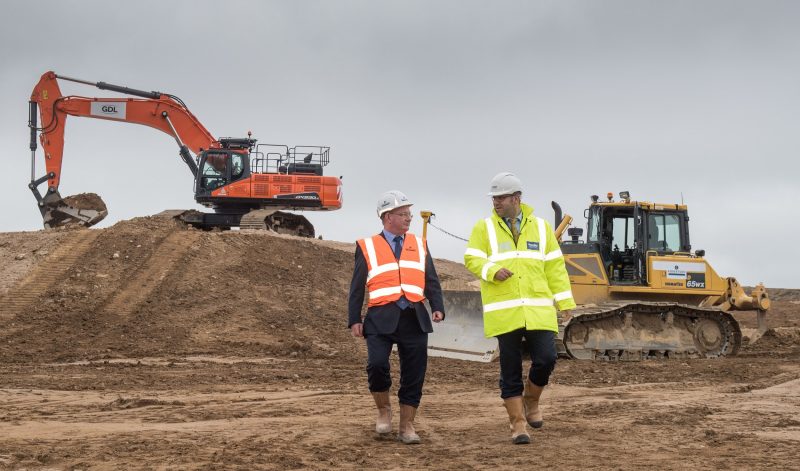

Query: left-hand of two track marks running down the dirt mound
left=0, top=230, right=99, bottom=319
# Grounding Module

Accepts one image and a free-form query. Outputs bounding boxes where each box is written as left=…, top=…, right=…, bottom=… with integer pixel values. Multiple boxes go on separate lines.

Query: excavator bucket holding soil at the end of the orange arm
left=39, top=191, right=108, bottom=229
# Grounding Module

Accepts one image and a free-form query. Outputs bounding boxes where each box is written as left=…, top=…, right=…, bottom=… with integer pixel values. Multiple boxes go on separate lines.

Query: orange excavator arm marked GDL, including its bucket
left=28, top=72, right=220, bottom=227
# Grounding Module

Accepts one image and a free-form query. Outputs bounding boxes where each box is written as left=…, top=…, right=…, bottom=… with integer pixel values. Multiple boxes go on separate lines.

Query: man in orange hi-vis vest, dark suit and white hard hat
left=348, top=191, right=444, bottom=445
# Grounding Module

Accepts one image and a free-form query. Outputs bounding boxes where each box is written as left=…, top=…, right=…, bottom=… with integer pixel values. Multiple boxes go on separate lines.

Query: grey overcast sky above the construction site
left=0, top=0, right=800, bottom=288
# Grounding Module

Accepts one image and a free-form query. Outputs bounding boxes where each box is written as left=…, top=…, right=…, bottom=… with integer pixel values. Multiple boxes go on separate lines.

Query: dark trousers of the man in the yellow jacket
left=497, top=329, right=558, bottom=399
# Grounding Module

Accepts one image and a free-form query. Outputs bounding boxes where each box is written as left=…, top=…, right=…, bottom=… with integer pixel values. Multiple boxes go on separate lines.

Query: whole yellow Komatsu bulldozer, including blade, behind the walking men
left=422, top=191, right=770, bottom=361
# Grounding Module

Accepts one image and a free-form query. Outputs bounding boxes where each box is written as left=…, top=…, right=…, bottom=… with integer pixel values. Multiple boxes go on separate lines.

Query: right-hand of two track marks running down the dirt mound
left=102, top=231, right=199, bottom=317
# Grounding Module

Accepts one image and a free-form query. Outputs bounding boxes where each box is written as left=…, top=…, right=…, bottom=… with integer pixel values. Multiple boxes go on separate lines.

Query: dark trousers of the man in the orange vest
left=365, top=307, right=428, bottom=407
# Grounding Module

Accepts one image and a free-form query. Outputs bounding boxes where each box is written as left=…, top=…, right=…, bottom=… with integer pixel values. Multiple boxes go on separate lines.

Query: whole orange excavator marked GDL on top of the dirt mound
left=28, top=72, right=342, bottom=237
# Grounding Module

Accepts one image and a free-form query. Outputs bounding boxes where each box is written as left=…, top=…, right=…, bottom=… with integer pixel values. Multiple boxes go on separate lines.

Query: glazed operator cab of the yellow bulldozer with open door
left=586, top=201, right=691, bottom=286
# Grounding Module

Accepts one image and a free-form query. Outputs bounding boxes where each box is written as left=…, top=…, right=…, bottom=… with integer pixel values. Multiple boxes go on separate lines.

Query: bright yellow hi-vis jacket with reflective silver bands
left=464, top=204, right=575, bottom=338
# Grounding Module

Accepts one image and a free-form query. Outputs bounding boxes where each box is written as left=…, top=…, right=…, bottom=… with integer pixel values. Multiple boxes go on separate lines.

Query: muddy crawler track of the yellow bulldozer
left=558, top=301, right=742, bottom=361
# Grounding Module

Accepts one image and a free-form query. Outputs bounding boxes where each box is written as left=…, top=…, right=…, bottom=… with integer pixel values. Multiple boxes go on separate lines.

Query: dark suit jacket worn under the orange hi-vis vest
left=347, top=232, right=444, bottom=334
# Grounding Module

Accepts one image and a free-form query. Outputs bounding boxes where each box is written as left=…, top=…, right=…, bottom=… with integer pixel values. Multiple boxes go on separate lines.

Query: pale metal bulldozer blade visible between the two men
left=428, top=291, right=498, bottom=363
